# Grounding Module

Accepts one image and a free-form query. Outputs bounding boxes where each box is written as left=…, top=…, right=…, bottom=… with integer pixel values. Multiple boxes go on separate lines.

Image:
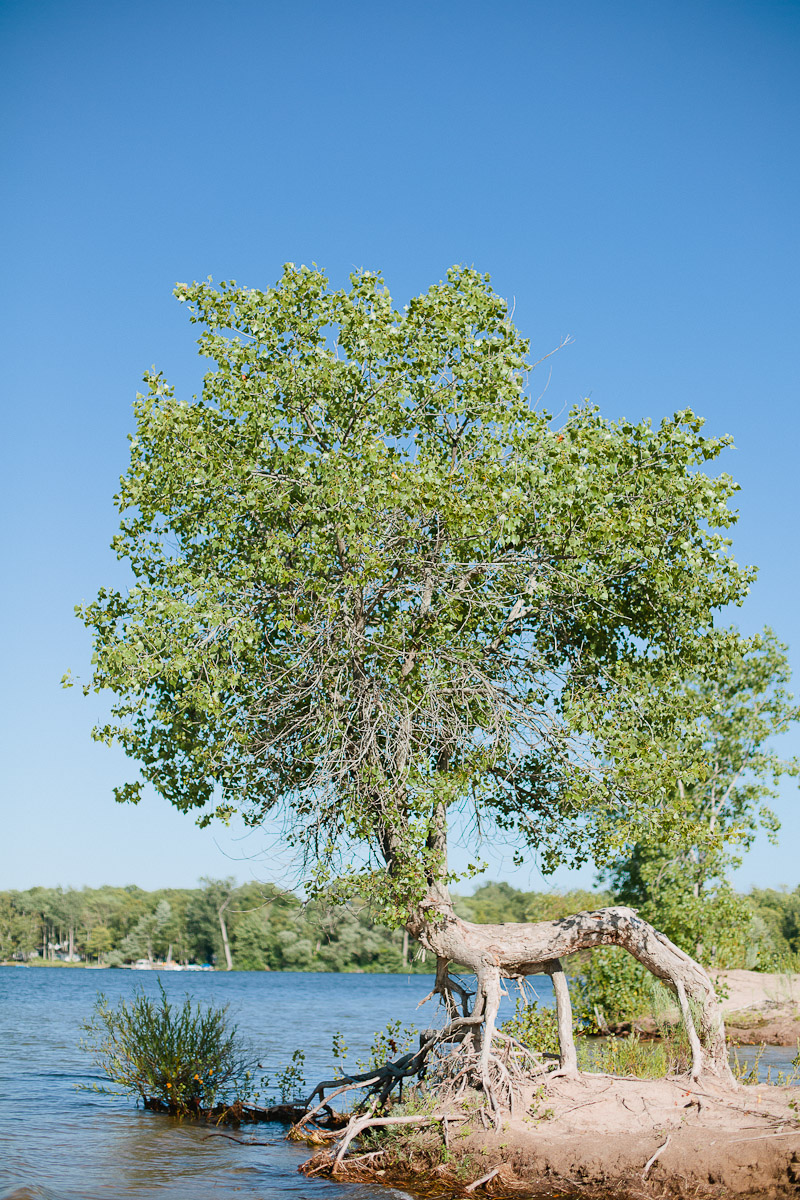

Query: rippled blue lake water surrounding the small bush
left=0, top=967, right=794, bottom=1200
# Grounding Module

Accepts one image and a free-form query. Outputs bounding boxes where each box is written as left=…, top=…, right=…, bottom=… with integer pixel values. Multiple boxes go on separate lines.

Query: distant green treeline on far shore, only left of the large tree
left=0, top=880, right=422, bottom=971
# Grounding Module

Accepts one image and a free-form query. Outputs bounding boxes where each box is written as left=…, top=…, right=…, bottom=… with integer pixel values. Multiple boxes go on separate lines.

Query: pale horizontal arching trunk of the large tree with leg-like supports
left=408, top=889, right=734, bottom=1085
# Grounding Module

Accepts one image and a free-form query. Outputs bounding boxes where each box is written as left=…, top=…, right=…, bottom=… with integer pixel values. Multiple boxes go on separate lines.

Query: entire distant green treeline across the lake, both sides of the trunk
left=0, top=880, right=800, bottom=972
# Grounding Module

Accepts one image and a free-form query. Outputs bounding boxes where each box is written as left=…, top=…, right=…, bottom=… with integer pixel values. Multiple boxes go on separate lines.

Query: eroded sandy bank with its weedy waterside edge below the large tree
left=309, top=1075, right=800, bottom=1200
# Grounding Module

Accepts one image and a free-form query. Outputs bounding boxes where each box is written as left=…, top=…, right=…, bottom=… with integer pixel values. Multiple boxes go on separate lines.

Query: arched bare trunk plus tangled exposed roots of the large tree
left=297, top=898, right=736, bottom=1172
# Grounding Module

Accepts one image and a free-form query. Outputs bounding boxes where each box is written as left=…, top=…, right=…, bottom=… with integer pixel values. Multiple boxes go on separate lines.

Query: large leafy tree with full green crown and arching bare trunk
left=79, top=264, right=752, bottom=1097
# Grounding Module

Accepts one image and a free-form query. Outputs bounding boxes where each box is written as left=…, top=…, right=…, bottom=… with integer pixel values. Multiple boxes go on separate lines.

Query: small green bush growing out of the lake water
left=83, top=982, right=254, bottom=1114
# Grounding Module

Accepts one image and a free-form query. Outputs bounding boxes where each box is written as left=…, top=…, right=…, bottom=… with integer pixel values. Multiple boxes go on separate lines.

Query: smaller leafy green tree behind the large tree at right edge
left=609, top=629, right=800, bottom=966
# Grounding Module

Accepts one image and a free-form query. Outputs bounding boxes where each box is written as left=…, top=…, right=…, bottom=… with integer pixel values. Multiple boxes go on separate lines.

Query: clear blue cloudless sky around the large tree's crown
left=0, top=0, right=800, bottom=888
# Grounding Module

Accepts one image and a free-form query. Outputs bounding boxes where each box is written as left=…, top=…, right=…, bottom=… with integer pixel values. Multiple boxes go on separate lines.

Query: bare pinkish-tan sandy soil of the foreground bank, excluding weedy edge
left=479, top=1075, right=800, bottom=1198
